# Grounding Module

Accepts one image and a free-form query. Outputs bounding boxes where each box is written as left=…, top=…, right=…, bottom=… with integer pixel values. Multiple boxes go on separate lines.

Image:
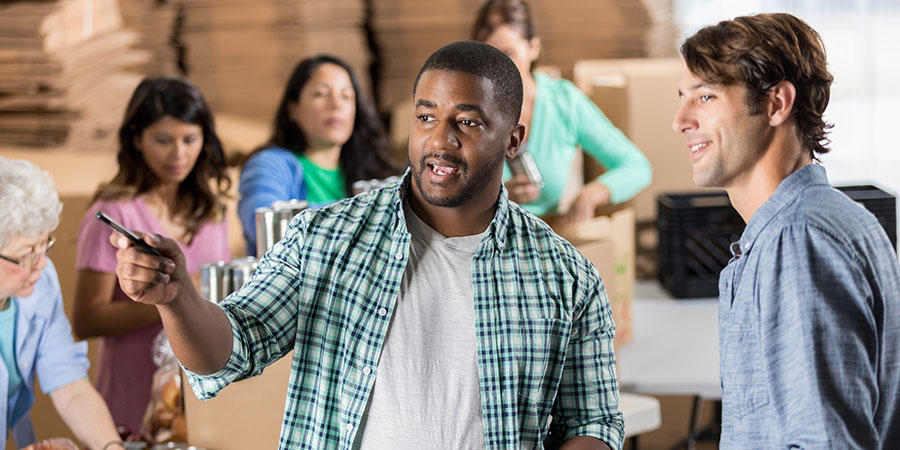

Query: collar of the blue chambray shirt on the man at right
left=732, top=163, right=830, bottom=255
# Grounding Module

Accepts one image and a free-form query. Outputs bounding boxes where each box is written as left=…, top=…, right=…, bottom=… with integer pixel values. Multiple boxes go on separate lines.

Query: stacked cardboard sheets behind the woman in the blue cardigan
left=180, top=0, right=371, bottom=122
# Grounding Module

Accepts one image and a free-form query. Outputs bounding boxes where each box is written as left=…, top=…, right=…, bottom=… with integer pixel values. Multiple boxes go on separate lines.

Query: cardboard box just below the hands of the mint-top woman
left=548, top=208, right=635, bottom=348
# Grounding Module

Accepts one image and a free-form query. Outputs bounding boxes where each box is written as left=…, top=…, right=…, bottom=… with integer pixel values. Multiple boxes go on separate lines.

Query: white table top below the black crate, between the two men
left=618, top=281, right=722, bottom=398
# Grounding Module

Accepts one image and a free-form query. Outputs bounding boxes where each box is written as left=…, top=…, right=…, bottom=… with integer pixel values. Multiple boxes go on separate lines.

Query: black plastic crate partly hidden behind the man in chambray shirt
left=656, top=186, right=897, bottom=298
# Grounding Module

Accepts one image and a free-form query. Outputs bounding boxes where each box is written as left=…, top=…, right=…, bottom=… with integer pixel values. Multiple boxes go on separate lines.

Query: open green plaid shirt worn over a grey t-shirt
left=188, top=171, right=624, bottom=450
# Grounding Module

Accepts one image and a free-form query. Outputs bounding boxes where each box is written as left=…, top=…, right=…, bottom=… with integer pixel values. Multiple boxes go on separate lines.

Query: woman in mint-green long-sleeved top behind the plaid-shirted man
left=473, top=0, right=651, bottom=222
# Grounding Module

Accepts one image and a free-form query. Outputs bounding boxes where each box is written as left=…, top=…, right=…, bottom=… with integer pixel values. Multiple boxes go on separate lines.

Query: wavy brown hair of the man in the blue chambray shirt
left=681, top=13, right=834, bottom=159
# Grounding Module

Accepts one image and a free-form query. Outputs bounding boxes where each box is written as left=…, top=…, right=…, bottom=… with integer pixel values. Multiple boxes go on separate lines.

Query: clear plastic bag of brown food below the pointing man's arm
left=141, top=330, right=187, bottom=444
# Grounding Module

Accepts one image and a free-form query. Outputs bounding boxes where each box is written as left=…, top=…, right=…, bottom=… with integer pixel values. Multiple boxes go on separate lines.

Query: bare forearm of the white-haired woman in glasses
left=50, top=378, right=119, bottom=450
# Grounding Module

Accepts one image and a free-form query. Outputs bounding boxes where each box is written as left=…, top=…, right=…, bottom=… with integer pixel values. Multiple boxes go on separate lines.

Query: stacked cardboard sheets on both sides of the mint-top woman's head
left=372, top=0, right=677, bottom=111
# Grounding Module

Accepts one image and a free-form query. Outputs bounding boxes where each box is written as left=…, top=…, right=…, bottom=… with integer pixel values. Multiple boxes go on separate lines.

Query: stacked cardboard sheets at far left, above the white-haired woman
left=0, top=0, right=147, bottom=151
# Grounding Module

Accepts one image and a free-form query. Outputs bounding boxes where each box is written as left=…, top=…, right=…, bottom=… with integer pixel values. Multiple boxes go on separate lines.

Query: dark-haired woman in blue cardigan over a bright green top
left=238, top=55, right=399, bottom=255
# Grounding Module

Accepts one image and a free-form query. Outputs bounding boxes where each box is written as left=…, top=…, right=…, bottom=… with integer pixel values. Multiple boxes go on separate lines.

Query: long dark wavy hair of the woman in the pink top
left=94, top=76, right=231, bottom=235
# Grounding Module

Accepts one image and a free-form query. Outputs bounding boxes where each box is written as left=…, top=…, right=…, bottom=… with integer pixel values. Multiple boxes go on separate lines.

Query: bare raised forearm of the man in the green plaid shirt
left=157, top=289, right=233, bottom=375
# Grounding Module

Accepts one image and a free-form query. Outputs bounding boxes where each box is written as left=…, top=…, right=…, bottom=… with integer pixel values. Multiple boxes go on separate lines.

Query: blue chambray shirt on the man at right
left=719, top=164, right=900, bottom=450
